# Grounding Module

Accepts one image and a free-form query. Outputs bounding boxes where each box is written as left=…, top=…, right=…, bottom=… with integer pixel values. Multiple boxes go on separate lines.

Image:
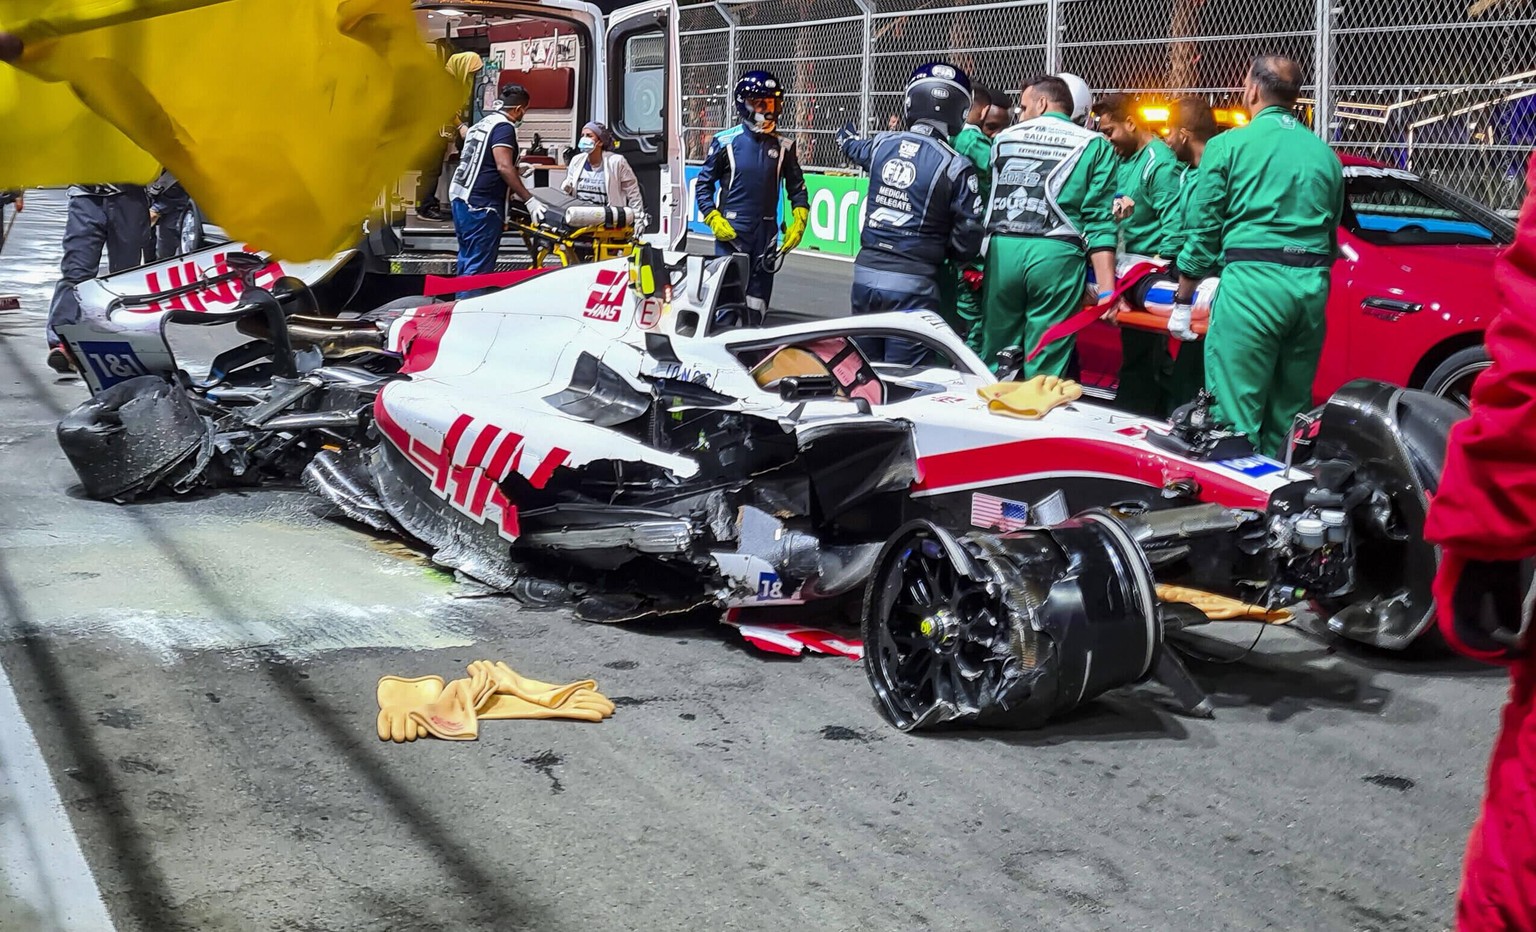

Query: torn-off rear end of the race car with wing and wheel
left=58, top=244, right=425, bottom=501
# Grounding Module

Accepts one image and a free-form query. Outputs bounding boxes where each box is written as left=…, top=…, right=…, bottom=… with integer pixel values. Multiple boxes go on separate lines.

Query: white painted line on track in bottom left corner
left=0, top=657, right=114, bottom=932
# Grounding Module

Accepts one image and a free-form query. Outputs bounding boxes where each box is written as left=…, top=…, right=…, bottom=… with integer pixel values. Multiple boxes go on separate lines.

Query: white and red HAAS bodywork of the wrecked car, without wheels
left=348, top=256, right=1424, bottom=644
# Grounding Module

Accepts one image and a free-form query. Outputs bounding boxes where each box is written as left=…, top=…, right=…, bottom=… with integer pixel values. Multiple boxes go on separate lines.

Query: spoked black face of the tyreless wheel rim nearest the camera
left=866, top=530, right=1011, bottom=729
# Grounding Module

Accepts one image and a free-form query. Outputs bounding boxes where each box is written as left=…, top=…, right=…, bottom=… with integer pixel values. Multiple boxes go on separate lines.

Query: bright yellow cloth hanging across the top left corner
left=0, top=0, right=462, bottom=259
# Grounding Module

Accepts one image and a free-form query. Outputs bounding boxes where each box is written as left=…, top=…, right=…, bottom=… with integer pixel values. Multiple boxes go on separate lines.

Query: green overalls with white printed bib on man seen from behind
left=980, top=112, right=1117, bottom=379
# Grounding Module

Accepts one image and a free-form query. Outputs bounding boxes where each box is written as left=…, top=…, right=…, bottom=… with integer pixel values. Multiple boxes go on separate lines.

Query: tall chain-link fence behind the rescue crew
left=682, top=0, right=1536, bottom=209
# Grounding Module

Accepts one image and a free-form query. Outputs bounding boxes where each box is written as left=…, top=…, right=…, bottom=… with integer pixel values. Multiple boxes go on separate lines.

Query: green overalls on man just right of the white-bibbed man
left=1115, top=138, right=1180, bottom=416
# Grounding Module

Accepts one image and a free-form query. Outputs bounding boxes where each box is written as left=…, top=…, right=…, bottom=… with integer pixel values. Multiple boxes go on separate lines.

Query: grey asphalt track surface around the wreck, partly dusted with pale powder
left=0, top=185, right=1504, bottom=932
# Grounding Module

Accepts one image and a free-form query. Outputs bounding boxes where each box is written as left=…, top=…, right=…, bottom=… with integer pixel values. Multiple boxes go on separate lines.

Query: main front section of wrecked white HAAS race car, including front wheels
left=61, top=249, right=1459, bottom=728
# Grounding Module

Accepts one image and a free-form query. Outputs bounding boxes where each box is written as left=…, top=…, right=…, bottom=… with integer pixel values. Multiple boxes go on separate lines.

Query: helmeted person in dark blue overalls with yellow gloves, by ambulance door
left=696, top=71, right=811, bottom=324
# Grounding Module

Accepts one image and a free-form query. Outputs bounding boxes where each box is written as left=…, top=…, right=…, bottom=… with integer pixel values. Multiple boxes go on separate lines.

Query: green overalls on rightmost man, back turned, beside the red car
left=1178, top=107, right=1344, bottom=456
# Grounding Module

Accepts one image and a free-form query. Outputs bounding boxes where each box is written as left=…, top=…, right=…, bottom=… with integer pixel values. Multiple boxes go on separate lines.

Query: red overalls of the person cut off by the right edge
left=1425, top=155, right=1536, bottom=930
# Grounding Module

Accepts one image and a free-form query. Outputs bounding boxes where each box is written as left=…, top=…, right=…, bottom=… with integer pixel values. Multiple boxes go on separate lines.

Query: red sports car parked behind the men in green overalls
left=1078, top=155, right=1514, bottom=405
